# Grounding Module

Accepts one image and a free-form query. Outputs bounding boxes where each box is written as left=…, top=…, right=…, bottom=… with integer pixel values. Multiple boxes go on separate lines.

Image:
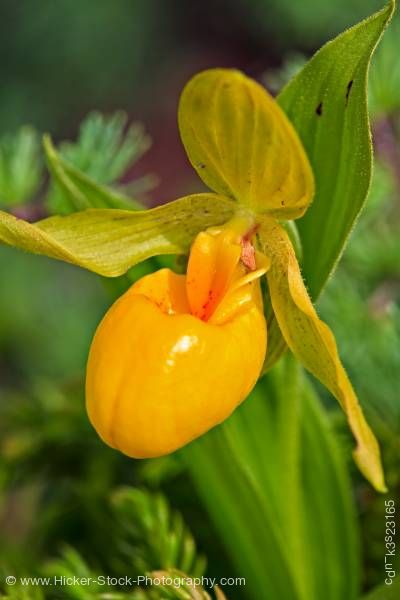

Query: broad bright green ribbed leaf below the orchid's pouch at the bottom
left=183, top=356, right=359, bottom=600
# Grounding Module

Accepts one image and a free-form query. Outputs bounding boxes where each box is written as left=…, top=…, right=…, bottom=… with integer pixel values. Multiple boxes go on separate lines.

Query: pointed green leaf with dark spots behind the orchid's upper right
left=278, top=0, right=394, bottom=298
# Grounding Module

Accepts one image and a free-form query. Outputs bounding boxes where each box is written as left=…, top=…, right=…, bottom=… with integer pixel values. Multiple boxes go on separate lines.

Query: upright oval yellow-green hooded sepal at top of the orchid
left=178, top=69, right=314, bottom=219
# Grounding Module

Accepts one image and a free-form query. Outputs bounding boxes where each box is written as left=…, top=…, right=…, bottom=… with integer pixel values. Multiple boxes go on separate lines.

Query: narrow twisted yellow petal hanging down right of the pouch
left=259, top=219, right=386, bottom=492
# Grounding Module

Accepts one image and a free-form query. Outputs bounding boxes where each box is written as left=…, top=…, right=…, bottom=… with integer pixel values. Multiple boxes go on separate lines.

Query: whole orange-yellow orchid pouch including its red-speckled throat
left=86, top=220, right=267, bottom=458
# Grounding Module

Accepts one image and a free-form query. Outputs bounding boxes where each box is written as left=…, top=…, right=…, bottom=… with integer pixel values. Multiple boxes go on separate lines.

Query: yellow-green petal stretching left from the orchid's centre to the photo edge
left=0, top=194, right=235, bottom=277
